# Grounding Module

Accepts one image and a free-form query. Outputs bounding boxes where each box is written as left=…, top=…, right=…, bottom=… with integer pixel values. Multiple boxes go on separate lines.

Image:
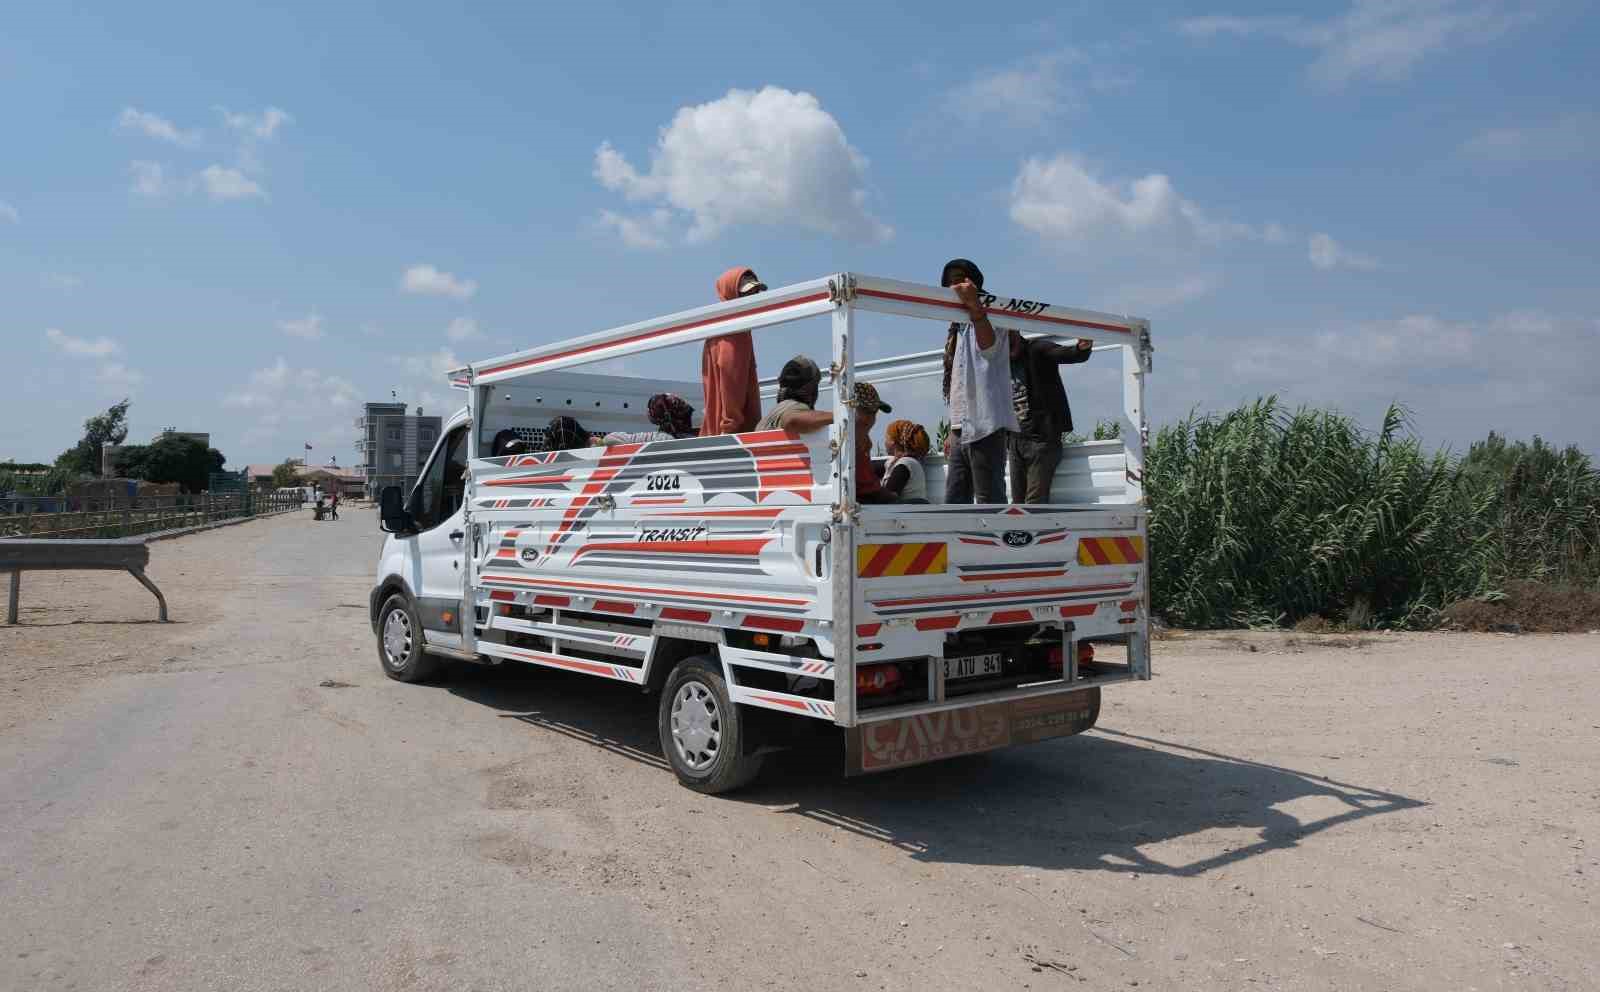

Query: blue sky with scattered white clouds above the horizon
left=0, top=0, right=1600, bottom=467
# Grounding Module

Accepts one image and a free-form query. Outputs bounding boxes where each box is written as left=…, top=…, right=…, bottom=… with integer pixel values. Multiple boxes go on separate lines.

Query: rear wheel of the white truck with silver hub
left=658, top=654, right=762, bottom=795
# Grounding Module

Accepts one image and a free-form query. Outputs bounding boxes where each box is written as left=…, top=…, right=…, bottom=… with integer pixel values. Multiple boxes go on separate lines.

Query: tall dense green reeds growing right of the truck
left=1146, top=398, right=1600, bottom=627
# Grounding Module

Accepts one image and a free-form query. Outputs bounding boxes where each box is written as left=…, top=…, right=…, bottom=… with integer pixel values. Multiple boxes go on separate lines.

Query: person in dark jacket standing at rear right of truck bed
left=1006, top=334, right=1094, bottom=502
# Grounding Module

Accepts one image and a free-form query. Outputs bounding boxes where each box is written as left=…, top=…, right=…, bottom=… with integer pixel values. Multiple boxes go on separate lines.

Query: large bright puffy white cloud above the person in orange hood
left=594, top=86, right=894, bottom=242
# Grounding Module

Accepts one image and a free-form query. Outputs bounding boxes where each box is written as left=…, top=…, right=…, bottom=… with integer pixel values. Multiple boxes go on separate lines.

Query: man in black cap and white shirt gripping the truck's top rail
left=939, top=258, right=1018, bottom=502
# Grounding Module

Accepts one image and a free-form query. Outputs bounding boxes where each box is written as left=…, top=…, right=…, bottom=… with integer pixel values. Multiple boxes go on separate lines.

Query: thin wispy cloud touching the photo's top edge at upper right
left=1178, top=0, right=1533, bottom=86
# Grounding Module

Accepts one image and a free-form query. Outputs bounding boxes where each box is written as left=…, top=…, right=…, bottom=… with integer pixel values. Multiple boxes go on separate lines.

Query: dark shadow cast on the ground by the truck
left=450, top=666, right=1424, bottom=875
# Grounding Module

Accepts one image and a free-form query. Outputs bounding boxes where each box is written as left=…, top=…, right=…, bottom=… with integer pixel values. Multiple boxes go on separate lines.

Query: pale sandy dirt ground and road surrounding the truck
left=0, top=509, right=1600, bottom=990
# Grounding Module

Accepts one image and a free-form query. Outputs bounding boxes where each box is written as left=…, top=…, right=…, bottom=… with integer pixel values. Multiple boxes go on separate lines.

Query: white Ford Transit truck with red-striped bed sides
left=371, top=272, right=1150, bottom=792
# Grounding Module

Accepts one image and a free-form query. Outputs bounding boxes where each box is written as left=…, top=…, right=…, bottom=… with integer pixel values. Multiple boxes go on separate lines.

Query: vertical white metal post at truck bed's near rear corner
left=832, top=283, right=856, bottom=726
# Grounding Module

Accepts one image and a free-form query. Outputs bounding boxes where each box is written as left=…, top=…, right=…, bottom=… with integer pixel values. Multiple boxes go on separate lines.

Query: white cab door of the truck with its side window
left=408, top=424, right=470, bottom=643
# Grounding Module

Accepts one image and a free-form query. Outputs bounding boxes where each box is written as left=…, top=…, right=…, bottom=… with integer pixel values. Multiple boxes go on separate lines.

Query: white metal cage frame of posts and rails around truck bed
left=448, top=272, right=1152, bottom=728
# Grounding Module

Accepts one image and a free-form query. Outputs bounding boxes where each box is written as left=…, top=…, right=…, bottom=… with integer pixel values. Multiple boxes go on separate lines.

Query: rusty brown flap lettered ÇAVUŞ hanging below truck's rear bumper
left=845, top=686, right=1099, bottom=776
